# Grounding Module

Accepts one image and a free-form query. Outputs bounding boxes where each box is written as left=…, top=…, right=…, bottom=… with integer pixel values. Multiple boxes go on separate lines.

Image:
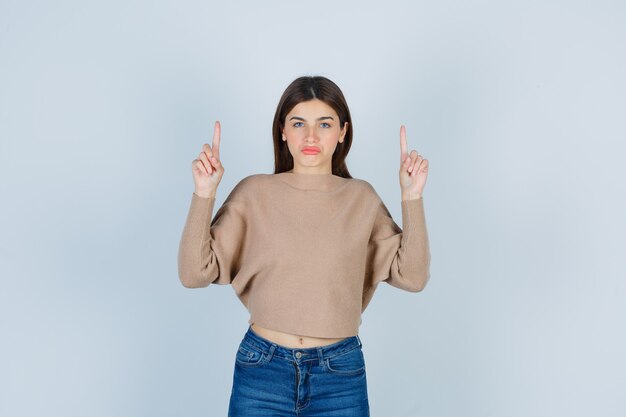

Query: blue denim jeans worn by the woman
left=228, top=326, right=370, bottom=417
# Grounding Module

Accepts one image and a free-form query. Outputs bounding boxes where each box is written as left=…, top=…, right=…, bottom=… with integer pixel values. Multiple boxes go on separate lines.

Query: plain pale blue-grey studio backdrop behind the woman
left=0, top=0, right=626, bottom=417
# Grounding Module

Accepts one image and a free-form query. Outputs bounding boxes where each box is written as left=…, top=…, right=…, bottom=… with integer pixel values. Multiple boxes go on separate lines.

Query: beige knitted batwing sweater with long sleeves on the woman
left=178, top=172, right=430, bottom=337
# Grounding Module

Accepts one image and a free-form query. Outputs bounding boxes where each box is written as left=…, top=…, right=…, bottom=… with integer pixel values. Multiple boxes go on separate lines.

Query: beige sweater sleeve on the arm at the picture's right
left=366, top=197, right=430, bottom=292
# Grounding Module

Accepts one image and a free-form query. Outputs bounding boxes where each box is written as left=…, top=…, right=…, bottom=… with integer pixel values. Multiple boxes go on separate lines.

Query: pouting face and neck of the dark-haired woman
left=283, top=99, right=348, bottom=174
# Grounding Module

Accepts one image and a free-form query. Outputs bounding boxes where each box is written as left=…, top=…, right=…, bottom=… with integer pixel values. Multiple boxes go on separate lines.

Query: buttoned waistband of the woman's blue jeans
left=243, top=325, right=362, bottom=363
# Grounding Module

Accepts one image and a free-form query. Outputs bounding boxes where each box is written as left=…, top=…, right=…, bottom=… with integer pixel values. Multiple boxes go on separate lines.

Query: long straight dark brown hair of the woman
left=272, top=76, right=352, bottom=178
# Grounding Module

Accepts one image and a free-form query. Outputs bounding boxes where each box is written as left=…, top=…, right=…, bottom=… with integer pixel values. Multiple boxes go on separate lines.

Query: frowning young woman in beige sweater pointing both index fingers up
left=178, top=76, right=430, bottom=417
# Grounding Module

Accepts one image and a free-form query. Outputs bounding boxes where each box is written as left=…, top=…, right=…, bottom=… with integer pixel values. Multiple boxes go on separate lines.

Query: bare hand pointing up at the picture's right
left=400, top=125, right=428, bottom=200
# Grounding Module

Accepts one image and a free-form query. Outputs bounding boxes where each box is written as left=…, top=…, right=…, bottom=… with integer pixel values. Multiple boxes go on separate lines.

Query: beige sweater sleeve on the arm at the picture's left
left=178, top=182, right=246, bottom=288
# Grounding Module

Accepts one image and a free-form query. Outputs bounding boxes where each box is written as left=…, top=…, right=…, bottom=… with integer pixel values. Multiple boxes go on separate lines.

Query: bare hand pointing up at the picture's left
left=191, top=120, right=224, bottom=198
